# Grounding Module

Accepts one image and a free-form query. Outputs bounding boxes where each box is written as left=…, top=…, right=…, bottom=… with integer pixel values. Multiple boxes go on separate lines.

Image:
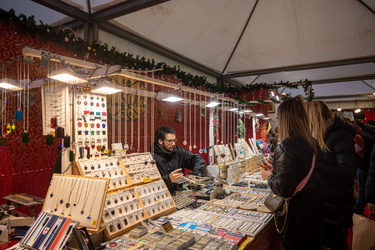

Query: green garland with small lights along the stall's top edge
left=0, top=9, right=314, bottom=102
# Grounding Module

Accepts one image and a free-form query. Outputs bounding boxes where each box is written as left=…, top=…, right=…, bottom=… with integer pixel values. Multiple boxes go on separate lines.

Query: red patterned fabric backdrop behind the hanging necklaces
left=0, top=22, right=268, bottom=215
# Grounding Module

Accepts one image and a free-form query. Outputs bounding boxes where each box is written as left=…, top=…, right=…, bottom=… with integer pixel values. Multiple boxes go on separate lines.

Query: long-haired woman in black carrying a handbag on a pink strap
left=262, top=96, right=324, bottom=250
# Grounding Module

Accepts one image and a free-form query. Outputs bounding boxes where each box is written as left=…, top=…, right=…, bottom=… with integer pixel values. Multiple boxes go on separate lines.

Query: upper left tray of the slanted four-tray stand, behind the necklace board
left=77, top=157, right=133, bottom=191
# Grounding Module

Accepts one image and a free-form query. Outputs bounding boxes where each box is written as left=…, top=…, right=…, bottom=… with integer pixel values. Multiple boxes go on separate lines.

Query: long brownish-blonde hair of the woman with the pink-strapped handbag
left=277, top=95, right=317, bottom=154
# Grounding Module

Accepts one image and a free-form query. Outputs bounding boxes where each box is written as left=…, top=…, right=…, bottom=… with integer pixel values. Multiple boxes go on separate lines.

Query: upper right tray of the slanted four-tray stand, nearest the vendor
left=121, top=152, right=161, bottom=184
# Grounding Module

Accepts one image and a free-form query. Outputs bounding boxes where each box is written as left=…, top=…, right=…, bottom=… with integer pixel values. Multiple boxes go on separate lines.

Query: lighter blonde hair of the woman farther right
left=306, top=101, right=335, bottom=152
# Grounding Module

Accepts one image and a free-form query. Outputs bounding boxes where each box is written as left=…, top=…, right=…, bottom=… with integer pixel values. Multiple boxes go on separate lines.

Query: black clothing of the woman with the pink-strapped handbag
left=268, top=136, right=324, bottom=249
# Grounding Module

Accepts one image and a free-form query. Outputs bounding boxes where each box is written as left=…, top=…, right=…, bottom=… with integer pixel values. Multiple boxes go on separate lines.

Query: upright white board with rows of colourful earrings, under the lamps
left=74, top=93, right=108, bottom=159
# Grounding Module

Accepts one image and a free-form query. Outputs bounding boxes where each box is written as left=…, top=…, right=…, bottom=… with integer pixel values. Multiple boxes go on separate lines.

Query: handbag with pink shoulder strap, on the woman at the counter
left=264, top=155, right=315, bottom=233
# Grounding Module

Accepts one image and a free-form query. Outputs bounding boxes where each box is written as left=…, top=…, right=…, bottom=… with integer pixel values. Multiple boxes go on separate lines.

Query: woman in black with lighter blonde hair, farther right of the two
left=306, top=101, right=357, bottom=249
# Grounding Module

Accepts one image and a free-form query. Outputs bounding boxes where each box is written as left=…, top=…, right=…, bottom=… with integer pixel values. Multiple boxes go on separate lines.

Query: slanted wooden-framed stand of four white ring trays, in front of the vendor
left=77, top=152, right=176, bottom=238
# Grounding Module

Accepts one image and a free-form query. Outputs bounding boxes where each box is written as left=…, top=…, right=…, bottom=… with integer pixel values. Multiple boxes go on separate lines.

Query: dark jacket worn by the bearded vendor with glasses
left=151, top=143, right=206, bottom=193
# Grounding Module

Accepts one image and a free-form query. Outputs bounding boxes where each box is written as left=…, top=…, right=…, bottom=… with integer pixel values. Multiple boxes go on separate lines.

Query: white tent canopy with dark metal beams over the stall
left=0, top=0, right=375, bottom=107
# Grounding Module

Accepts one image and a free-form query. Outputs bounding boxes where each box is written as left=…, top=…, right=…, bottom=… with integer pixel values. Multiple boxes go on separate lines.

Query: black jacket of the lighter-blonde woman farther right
left=322, top=116, right=357, bottom=226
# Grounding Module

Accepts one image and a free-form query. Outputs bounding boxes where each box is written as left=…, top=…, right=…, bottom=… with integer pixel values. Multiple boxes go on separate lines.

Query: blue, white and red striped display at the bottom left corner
left=20, top=212, right=79, bottom=250
